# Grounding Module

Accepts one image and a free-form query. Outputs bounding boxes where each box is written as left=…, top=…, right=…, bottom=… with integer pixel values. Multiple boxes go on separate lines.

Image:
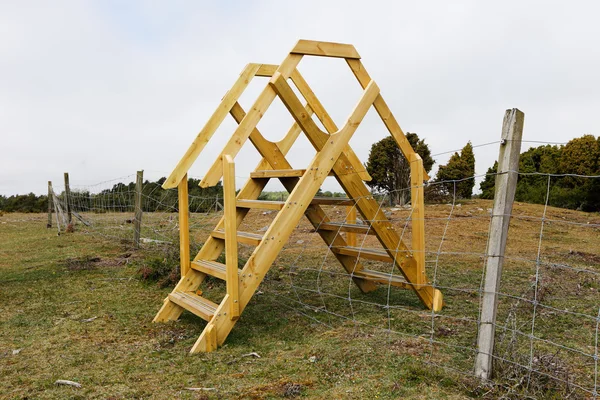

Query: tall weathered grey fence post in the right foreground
left=475, top=108, right=525, bottom=380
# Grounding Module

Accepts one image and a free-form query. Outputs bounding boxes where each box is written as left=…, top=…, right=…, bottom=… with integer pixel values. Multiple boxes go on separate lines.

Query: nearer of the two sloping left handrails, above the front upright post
left=200, top=54, right=302, bottom=188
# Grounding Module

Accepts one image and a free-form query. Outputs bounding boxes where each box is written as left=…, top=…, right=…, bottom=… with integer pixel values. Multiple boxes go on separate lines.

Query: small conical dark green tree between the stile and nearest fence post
left=436, top=142, right=475, bottom=199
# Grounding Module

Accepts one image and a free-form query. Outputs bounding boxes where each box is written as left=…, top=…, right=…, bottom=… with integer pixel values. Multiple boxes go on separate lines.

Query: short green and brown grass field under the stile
left=0, top=200, right=600, bottom=399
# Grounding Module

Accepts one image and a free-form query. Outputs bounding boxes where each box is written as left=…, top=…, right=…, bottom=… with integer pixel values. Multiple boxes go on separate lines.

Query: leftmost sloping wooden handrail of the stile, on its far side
left=163, top=64, right=261, bottom=189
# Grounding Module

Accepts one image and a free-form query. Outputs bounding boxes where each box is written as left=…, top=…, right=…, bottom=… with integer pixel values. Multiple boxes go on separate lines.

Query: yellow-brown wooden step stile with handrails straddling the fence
left=154, top=41, right=443, bottom=353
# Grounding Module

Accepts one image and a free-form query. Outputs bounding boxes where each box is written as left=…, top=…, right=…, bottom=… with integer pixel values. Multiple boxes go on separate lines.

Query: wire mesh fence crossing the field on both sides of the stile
left=48, top=166, right=600, bottom=398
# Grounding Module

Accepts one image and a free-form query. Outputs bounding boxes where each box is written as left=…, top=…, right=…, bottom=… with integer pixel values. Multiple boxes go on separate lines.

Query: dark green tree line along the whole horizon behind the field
left=0, top=132, right=600, bottom=212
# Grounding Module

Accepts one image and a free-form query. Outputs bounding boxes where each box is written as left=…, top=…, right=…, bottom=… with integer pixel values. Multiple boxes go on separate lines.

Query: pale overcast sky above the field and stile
left=0, top=0, right=600, bottom=195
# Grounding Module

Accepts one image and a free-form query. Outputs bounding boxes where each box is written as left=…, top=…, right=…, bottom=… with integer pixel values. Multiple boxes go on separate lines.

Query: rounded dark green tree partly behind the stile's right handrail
left=365, top=132, right=435, bottom=204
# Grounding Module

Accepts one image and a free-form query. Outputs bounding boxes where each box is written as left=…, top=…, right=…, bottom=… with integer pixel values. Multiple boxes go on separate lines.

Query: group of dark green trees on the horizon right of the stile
left=365, top=133, right=600, bottom=211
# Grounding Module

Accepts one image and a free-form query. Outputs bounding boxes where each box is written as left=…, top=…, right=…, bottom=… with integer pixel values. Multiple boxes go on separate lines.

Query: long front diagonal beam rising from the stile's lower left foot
left=193, top=77, right=379, bottom=351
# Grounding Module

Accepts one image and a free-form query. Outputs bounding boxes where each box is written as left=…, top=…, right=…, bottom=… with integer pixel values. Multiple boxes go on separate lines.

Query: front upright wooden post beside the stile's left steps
left=223, top=154, right=240, bottom=319
